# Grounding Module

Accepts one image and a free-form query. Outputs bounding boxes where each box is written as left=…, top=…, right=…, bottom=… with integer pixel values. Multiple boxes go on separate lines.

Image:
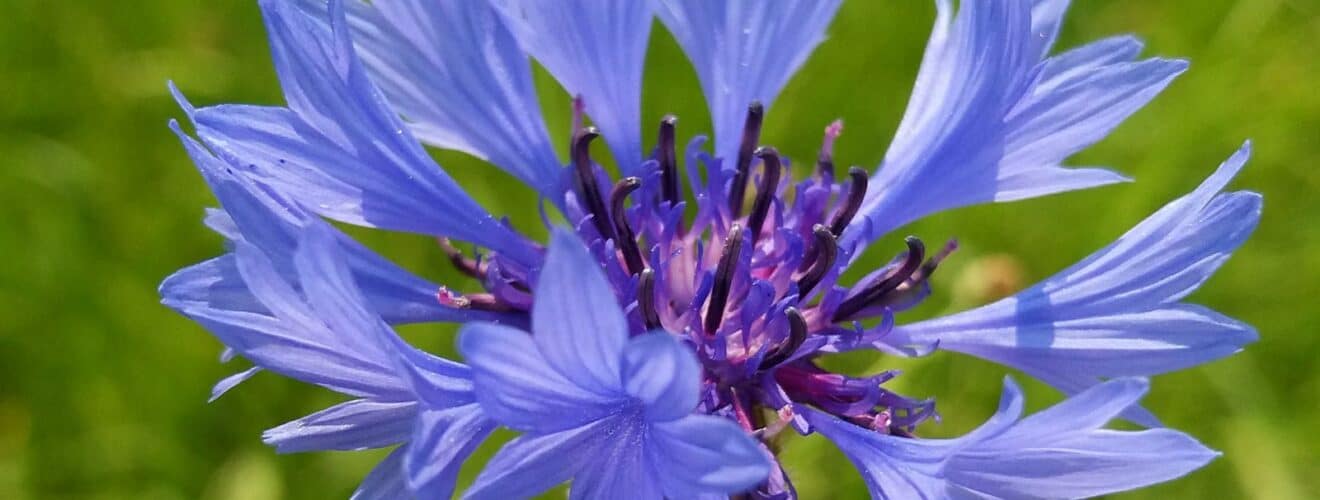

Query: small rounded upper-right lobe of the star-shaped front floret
left=623, top=332, right=701, bottom=422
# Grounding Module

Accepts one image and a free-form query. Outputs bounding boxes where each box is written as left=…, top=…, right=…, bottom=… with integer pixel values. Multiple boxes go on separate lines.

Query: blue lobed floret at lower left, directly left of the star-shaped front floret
left=167, top=220, right=494, bottom=497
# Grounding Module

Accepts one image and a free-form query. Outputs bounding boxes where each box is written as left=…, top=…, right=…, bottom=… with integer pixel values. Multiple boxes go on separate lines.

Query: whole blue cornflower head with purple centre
left=161, top=0, right=1261, bottom=499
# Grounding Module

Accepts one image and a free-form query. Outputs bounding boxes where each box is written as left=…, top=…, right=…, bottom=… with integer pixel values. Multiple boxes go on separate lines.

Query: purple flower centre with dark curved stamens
left=440, top=103, right=956, bottom=431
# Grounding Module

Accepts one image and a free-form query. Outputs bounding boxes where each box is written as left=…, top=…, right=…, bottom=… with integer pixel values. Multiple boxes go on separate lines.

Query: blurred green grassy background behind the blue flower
left=0, top=0, right=1320, bottom=499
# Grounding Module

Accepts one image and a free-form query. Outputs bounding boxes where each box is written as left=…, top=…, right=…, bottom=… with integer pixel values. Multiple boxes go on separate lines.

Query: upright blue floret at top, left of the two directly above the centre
left=491, top=0, right=651, bottom=175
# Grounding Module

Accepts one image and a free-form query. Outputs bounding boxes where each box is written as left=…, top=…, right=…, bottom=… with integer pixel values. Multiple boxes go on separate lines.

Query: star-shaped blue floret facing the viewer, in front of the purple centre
left=459, top=230, right=770, bottom=499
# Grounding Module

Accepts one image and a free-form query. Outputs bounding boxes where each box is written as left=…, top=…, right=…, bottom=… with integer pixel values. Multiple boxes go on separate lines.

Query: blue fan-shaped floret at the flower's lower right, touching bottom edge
left=804, top=379, right=1217, bottom=499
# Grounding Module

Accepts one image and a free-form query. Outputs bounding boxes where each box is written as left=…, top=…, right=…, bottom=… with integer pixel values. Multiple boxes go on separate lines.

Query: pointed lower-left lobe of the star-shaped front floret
left=463, top=420, right=615, bottom=500
